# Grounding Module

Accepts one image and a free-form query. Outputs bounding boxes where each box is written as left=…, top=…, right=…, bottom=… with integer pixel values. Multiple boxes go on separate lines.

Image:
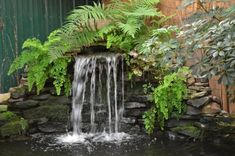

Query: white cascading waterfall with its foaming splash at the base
left=59, top=53, right=127, bottom=142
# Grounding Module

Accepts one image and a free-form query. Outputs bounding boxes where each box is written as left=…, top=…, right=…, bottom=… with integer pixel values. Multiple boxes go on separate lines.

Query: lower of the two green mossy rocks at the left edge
left=0, top=118, right=28, bottom=137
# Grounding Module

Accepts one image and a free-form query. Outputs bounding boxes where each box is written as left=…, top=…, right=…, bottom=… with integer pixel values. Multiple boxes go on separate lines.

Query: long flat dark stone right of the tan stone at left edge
left=9, top=100, right=39, bottom=110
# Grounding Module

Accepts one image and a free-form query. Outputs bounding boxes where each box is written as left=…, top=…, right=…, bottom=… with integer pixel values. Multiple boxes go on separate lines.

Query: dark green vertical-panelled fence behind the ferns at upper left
left=0, top=0, right=99, bottom=93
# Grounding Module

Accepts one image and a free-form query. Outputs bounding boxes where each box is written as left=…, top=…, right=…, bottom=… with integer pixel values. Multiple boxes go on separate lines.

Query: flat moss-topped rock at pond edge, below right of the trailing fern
left=171, top=125, right=201, bottom=139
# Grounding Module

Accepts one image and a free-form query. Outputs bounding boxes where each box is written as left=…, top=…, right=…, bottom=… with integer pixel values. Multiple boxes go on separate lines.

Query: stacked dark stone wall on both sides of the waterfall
left=0, top=70, right=235, bottom=143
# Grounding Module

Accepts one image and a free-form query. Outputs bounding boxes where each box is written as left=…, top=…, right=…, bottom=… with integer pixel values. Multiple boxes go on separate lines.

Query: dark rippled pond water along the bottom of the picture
left=0, top=135, right=235, bottom=156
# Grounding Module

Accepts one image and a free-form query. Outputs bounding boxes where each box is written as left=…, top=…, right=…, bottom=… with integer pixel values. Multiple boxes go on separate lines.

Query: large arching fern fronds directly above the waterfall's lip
left=50, top=0, right=164, bottom=58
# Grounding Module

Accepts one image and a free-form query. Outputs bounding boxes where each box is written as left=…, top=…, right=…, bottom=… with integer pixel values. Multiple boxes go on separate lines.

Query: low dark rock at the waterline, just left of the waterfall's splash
left=38, top=122, right=67, bottom=133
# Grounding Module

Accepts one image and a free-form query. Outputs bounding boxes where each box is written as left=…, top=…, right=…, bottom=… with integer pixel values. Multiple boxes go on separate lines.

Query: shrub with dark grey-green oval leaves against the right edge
left=178, top=3, right=235, bottom=85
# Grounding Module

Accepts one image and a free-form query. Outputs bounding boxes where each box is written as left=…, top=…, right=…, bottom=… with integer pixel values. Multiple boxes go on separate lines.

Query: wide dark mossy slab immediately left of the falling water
left=23, top=105, right=69, bottom=121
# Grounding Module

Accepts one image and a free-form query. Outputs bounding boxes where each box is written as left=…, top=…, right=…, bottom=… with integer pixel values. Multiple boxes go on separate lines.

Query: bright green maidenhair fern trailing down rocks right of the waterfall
left=143, top=67, right=189, bottom=134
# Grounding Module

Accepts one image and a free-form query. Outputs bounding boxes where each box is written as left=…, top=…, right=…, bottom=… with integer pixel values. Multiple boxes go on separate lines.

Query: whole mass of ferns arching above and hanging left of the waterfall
left=8, top=0, right=164, bottom=94
